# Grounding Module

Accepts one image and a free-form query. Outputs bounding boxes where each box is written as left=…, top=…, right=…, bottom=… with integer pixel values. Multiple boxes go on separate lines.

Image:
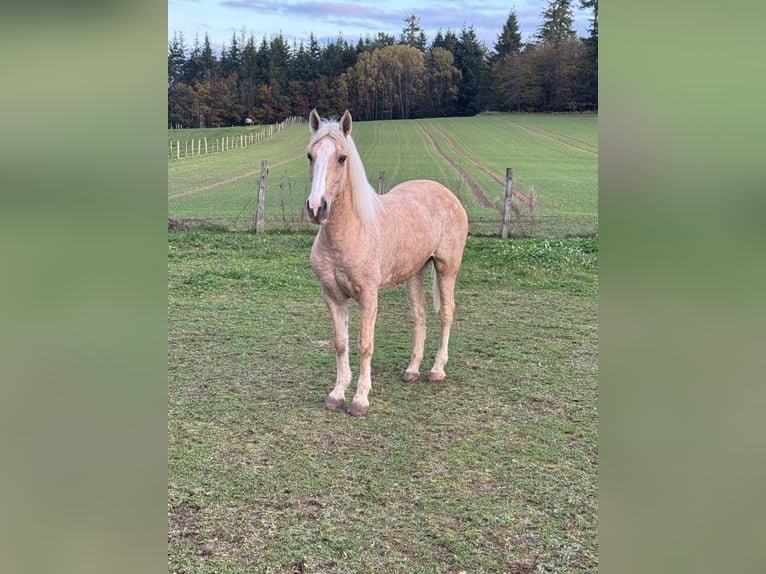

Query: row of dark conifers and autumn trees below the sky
left=168, top=0, right=598, bottom=127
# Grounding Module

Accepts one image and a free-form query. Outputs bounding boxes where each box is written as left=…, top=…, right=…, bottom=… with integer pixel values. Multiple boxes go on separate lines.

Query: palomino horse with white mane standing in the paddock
left=306, top=110, right=468, bottom=416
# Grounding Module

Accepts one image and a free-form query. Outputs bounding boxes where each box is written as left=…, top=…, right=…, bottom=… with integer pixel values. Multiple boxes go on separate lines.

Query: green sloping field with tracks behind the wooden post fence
left=168, top=114, right=598, bottom=232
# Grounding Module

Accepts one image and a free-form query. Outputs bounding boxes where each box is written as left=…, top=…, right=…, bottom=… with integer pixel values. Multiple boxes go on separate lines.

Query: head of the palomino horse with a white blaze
left=306, top=109, right=351, bottom=225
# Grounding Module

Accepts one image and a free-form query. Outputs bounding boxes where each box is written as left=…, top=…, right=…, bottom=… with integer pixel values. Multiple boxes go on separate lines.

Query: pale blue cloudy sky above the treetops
left=168, top=0, right=592, bottom=52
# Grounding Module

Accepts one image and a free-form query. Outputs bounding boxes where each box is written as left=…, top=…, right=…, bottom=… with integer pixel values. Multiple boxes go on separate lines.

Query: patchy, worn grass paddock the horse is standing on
left=168, top=232, right=598, bottom=574
